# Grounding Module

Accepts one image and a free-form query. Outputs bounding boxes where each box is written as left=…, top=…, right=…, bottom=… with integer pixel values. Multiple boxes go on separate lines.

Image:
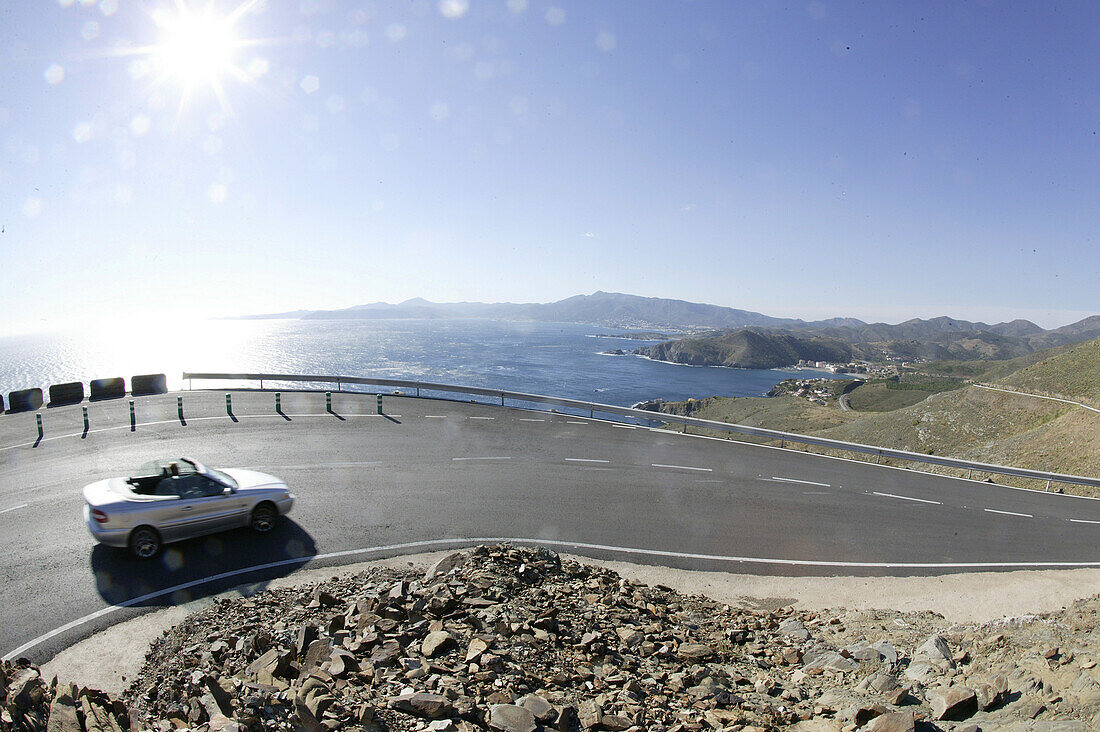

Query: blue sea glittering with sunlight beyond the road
left=0, top=319, right=832, bottom=406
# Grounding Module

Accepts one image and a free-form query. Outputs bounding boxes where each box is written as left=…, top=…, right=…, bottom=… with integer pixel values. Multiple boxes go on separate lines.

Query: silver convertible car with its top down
left=84, top=458, right=294, bottom=558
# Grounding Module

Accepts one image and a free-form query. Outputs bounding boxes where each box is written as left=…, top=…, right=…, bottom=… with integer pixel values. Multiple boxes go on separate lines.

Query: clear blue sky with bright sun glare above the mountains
left=0, top=0, right=1100, bottom=332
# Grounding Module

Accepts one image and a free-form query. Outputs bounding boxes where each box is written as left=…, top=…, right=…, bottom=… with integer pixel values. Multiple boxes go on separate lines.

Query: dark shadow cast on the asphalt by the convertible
left=89, top=517, right=317, bottom=607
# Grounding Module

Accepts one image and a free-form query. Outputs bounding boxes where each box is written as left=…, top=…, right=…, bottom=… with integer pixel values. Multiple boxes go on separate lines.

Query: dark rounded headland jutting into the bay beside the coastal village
left=635, top=328, right=851, bottom=369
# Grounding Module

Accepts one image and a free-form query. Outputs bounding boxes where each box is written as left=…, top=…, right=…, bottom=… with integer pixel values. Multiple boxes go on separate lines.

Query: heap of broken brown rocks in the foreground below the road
left=0, top=546, right=1100, bottom=732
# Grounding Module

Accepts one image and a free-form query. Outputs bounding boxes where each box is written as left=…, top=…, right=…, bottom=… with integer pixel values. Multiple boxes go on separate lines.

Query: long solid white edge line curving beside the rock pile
left=12, top=534, right=1100, bottom=660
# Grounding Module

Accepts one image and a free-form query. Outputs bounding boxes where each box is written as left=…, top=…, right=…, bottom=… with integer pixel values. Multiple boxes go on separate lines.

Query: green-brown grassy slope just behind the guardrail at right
left=642, top=339, right=1100, bottom=495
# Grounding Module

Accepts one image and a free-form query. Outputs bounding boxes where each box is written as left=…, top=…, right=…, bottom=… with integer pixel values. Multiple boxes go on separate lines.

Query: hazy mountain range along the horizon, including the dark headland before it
left=245, top=292, right=1100, bottom=368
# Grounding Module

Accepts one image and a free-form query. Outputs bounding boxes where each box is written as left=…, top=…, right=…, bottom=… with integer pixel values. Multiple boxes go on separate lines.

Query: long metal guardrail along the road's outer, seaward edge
left=183, top=372, right=1100, bottom=488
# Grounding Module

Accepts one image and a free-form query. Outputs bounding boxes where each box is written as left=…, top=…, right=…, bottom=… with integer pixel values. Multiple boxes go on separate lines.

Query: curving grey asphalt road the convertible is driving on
left=0, top=392, right=1100, bottom=662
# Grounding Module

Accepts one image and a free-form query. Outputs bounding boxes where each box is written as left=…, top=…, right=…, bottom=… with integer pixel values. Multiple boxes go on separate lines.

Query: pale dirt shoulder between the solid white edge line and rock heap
left=42, top=551, right=1100, bottom=693
